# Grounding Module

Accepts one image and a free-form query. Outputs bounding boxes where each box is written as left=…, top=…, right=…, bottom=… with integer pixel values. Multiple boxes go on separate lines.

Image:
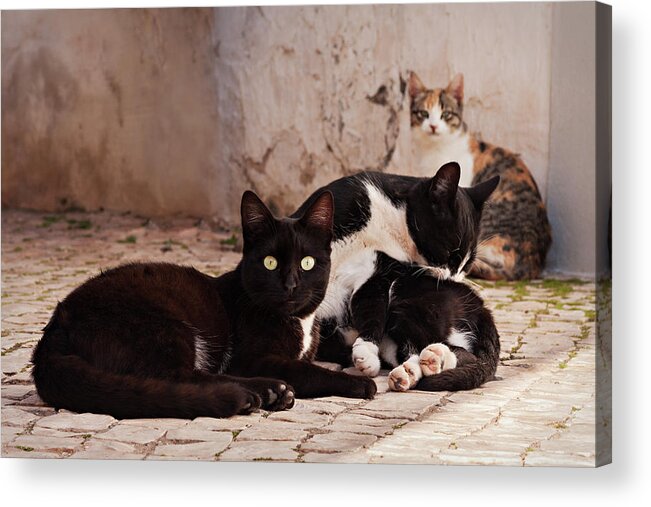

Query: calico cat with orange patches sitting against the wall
left=408, top=72, right=551, bottom=280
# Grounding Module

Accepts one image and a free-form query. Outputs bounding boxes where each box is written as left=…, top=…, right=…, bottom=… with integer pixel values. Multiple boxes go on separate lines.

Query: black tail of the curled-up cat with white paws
left=415, top=309, right=500, bottom=391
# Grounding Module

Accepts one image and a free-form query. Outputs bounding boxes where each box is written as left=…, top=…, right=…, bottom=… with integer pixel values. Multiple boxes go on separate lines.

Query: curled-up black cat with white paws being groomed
left=350, top=253, right=500, bottom=391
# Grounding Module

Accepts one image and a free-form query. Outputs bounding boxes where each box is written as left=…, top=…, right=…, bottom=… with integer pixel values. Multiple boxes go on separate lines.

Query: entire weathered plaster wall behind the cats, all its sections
left=2, top=3, right=608, bottom=272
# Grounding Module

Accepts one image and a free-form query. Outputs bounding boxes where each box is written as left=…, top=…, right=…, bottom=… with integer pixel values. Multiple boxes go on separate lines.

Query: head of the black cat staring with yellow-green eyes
left=241, top=191, right=334, bottom=317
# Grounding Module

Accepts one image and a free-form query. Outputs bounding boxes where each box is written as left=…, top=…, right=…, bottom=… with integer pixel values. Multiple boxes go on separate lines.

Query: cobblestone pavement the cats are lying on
left=1, top=210, right=610, bottom=466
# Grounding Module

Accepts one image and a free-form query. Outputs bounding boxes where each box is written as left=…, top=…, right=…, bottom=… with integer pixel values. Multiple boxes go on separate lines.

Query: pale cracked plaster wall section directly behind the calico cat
left=214, top=4, right=551, bottom=219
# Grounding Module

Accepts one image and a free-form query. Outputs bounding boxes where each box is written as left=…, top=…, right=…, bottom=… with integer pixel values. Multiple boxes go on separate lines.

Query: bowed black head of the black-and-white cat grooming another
left=407, top=162, right=500, bottom=279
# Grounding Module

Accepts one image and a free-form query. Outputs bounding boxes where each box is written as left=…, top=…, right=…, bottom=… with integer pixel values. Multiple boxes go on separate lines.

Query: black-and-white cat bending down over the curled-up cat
left=297, top=162, right=499, bottom=376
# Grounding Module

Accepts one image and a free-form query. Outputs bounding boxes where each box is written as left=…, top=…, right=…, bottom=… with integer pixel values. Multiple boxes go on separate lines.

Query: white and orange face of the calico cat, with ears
left=407, top=72, right=465, bottom=140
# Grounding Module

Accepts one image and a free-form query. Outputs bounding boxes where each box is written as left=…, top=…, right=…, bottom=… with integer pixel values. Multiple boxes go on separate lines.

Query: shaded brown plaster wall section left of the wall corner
left=2, top=9, right=221, bottom=215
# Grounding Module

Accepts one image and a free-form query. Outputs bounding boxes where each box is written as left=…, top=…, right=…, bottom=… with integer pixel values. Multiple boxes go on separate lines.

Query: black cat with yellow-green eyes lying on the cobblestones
left=32, top=192, right=376, bottom=418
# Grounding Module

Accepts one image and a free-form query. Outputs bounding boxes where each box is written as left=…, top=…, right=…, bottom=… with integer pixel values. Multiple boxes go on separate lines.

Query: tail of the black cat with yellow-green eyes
left=32, top=326, right=260, bottom=419
